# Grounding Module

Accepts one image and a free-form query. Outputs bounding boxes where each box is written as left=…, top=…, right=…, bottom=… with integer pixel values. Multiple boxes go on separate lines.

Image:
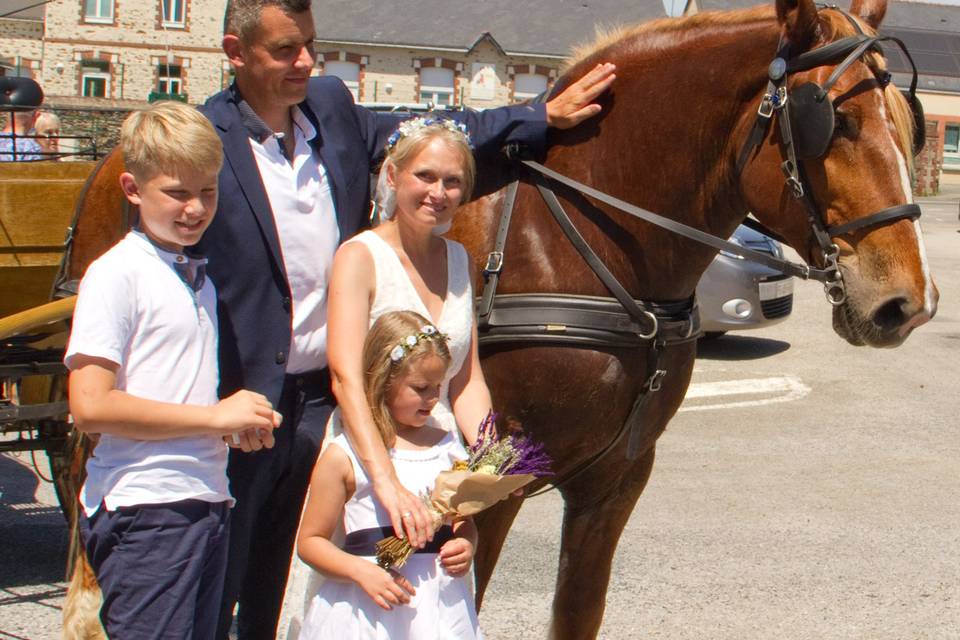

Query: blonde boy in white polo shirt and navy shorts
left=64, top=102, right=279, bottom=639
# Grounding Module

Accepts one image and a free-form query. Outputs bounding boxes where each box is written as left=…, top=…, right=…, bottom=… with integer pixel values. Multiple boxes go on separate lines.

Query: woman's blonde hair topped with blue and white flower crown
left=376, top=118, right=477, bottom=220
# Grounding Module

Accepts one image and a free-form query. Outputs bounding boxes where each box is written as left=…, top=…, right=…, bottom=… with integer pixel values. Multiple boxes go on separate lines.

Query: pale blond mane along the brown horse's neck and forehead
left=561, top=5, right=915, bottom=175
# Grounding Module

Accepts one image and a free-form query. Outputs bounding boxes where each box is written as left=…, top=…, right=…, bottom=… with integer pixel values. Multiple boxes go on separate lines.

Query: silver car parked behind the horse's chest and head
left=697, top=225, right=793, bottom=338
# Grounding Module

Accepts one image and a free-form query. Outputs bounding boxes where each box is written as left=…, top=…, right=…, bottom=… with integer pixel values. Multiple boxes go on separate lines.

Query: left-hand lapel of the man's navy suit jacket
left=222, top=110, right=286, bottom=277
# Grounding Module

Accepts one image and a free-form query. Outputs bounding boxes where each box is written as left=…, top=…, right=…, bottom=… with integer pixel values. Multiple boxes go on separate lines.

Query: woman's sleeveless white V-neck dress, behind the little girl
left=348, top=231, right=473, bottom=437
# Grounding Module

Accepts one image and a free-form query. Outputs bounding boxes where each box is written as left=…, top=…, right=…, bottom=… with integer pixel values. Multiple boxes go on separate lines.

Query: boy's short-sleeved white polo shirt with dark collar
left=64, top=231, right=232, bottom=516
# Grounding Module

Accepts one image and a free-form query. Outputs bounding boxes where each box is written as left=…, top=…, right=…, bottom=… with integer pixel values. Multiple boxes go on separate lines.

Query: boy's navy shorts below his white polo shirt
left=80, top=500, right=230, bottom=640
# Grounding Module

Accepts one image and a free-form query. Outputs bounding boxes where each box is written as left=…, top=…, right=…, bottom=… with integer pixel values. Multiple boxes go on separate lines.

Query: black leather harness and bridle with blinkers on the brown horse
left=477, top=12, right=925, bottom=497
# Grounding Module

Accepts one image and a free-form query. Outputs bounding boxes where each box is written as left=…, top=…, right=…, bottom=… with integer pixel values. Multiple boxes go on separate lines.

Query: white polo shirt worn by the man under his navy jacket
left=249, top=107, right=340, bottom=373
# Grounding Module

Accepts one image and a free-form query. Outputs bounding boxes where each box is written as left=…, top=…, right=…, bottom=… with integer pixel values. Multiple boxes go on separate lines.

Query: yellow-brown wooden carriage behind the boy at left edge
left=0, top=78, right=123, bottom=520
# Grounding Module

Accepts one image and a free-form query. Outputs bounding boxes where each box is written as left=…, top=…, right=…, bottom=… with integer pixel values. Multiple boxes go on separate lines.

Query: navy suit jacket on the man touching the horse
left=198, top=77, right=546, bottom=406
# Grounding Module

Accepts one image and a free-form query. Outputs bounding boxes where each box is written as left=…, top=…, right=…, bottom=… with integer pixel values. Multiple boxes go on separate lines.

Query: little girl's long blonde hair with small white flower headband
left=362, top=311, right=450, bottom=449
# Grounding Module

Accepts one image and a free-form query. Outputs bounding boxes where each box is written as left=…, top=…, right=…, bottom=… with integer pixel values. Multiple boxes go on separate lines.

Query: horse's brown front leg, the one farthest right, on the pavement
left=549, top=446, right=654, bottom=640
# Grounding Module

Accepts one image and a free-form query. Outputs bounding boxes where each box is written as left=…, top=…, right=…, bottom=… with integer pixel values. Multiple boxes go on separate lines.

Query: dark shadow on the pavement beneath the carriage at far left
left=0, top=453, right=69, bottom=588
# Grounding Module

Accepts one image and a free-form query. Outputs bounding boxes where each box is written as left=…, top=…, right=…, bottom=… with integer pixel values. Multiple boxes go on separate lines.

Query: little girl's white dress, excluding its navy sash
left=299, top=412, right=483, bottom=640
